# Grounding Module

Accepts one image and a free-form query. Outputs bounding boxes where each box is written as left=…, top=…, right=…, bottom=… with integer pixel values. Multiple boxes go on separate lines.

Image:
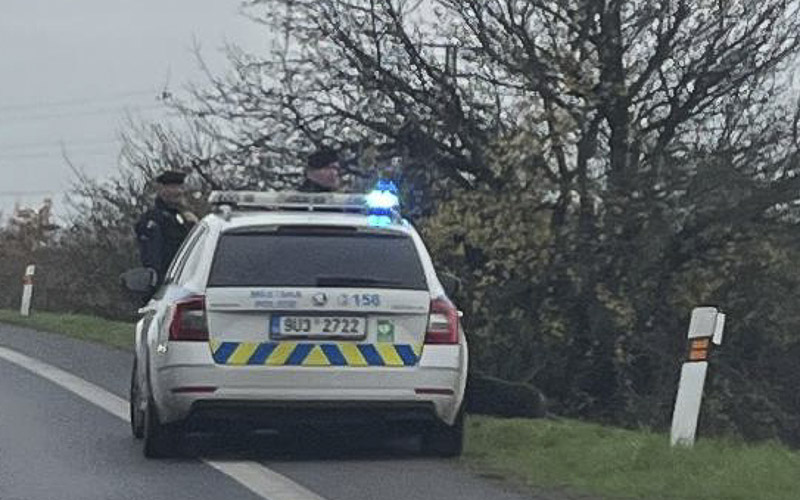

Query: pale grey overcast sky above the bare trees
left=0, top=0, right=268, bottom=219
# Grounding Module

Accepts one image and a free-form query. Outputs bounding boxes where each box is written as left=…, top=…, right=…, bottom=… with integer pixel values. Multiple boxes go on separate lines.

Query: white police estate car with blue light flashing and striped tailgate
left=130, top=190, right=467, bottom=457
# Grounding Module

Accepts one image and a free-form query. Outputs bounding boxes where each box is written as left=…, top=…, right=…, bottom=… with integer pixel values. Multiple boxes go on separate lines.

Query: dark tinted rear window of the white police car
left=208, top=231, right=427, bottom=290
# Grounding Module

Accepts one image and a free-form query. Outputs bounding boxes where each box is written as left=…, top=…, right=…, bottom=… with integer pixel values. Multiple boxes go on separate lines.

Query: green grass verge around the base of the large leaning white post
left=465, top=417, right=800, bottom=500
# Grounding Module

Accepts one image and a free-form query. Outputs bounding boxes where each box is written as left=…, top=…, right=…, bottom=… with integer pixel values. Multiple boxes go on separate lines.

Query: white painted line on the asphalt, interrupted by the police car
left=0, top=347, right=325, bottom=500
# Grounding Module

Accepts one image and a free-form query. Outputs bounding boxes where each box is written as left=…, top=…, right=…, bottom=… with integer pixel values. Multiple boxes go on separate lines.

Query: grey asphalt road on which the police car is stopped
left=0, top=324, right=552, bottom=500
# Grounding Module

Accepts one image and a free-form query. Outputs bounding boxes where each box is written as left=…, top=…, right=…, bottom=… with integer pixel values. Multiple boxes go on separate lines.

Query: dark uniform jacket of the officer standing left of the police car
left=136, top=198, right=194, bottom=285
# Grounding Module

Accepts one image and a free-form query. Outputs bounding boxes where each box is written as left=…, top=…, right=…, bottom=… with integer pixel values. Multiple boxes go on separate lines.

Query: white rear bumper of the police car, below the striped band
left=152, top=346, right=466, bottom=424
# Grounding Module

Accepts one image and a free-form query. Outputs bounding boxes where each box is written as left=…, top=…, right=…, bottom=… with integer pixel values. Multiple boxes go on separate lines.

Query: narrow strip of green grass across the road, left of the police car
left=0, top=309, right=134, bottom=350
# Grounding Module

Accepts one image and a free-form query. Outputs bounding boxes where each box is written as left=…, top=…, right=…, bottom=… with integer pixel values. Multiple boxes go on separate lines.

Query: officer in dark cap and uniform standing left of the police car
left=135, top=171, right=197, bottom=285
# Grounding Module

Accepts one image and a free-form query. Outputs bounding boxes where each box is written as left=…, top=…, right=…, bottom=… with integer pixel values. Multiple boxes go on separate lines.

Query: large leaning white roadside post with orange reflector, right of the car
left=671, top=307, right=725, bottom=447
